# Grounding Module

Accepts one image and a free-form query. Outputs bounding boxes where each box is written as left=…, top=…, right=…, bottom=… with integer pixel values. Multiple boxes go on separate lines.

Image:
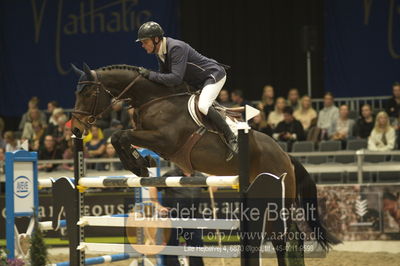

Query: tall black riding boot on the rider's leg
left=207, top=107, right=238, bottom=161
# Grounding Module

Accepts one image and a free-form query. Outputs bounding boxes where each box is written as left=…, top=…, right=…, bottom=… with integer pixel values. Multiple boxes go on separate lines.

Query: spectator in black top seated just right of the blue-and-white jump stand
left=38, top=135, right=62, bottom=172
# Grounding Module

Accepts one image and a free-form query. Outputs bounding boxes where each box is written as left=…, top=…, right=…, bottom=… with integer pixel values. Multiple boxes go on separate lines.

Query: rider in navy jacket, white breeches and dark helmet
left=136, top=21, right=238, bottom=160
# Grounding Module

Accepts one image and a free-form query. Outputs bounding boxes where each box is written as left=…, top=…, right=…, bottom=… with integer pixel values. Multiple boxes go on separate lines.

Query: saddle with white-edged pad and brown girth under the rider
left=170, top=93, right=244, bottom=173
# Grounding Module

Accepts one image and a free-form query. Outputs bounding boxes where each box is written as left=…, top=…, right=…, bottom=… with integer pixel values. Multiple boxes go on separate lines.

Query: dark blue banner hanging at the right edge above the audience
left=324, top=0, right=400, bottom=97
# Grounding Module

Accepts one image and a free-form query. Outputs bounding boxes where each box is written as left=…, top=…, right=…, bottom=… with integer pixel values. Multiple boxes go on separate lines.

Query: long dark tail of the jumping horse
left=290, top=156, right=342, bottom=250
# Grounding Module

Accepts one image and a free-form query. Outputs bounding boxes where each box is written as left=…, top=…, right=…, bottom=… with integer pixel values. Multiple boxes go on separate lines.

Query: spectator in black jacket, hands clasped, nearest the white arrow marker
left=273, top=106, right=306, bottom=150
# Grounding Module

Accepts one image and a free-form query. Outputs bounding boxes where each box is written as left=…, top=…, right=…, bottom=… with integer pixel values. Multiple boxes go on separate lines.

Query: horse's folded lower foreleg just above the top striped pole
left=111, top=130, right=148, bottom=176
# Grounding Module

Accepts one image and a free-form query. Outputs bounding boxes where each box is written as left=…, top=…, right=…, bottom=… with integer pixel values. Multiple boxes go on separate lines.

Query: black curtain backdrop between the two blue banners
left=181, top=0, right=323, bottom=100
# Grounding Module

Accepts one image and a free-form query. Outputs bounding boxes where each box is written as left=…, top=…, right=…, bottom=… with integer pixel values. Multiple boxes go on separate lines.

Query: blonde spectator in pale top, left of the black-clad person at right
left=328, top=104, right=355, bottom=141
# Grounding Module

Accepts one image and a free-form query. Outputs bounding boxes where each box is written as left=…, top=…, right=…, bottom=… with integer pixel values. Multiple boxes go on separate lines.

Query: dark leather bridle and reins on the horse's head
left=71, top=70, right=141, bottom=128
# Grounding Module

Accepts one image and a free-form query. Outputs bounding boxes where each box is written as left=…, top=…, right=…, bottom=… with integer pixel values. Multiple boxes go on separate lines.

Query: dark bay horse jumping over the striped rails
left=72, top=64, right=337, bottom=265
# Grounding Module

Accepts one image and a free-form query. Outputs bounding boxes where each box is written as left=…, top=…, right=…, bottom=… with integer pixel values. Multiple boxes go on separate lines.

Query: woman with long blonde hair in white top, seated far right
left=368, top=112, right=396, bottom=151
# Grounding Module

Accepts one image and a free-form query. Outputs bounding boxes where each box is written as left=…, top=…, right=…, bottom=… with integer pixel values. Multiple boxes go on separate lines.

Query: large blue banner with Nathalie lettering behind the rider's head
left=0, top=0, right=179, bottom=116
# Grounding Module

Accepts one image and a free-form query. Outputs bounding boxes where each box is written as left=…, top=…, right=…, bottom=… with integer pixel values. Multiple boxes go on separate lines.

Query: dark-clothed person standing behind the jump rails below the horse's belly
left=149, top=168, right=204, bottom=266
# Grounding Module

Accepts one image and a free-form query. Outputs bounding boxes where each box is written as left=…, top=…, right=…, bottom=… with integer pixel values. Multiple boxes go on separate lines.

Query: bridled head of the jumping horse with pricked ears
left=72, top=63, right=113, bottom=136
